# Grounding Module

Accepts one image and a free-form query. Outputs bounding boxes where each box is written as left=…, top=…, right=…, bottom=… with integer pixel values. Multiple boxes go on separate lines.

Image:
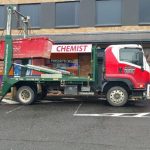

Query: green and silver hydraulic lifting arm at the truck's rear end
left=0, top=6, right=29, bottom=100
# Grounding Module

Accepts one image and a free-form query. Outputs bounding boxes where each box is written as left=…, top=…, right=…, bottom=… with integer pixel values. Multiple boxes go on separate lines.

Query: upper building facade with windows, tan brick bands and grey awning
left=0, top=0, right=150, bottom=61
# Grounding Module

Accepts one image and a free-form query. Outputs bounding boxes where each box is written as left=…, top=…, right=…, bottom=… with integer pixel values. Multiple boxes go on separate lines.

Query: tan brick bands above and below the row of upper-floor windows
left=0, top=0, right=150, bottom=38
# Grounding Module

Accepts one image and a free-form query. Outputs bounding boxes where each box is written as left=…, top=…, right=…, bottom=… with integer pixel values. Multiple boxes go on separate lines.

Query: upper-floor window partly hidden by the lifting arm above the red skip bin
left=19, top=4, right=41, bottom=28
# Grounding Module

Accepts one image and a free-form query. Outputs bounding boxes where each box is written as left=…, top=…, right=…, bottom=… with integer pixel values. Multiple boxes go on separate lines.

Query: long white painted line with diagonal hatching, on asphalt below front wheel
left=73, top=112, right=150, bottom=118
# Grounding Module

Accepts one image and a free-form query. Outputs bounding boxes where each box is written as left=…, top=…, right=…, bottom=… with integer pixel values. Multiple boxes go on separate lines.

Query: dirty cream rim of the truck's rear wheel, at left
left=19, top=89, right=31, bottom=102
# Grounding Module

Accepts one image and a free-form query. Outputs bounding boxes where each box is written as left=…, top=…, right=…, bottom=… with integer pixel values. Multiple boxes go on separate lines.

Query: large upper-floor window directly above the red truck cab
left=96, top=0, right=122, bottom=26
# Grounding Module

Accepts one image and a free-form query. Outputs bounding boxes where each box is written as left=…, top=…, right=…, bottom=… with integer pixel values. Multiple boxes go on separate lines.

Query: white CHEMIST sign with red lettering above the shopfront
left=51, top=44, right=92, bottom=53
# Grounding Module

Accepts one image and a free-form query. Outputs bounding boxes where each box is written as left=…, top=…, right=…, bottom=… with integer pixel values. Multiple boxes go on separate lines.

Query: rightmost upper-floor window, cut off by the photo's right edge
left=139, top=0, right=150, bottom=24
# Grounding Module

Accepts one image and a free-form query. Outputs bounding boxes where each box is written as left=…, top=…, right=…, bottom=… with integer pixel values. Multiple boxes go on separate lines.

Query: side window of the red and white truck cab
left=119, top=48, right=141, bottom=65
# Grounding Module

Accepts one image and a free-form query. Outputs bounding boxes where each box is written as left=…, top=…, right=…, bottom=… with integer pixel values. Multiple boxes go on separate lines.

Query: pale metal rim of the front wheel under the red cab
left=110, top=89, right=125, bottom=104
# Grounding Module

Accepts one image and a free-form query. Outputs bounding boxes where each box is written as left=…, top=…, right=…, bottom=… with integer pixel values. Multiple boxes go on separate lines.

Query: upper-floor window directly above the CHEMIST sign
left=56, top=2, right=79, bottom=27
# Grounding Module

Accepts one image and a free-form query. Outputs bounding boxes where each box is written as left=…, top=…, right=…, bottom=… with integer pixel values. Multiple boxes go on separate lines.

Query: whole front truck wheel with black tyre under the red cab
left=107, top=86, right=128, bottom=106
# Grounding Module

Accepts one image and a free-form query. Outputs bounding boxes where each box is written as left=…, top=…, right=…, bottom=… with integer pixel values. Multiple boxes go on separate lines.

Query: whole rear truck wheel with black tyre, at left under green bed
left=16, top=86, right=36, bottom=105
